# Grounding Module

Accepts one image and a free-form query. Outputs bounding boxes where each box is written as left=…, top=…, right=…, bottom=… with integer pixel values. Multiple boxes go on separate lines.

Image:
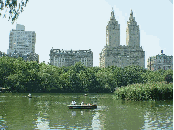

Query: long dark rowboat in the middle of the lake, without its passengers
left=67, top=104, right=97, bottom=109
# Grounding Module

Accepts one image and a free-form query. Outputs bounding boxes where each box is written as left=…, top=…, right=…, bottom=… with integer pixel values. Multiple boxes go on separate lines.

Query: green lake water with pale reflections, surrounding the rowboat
left=0, top=93, right=173, bottom=130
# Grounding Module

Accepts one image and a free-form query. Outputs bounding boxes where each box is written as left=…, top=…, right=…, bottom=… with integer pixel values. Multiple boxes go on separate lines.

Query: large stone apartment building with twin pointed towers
left=99, top=10, right=145, bottom=68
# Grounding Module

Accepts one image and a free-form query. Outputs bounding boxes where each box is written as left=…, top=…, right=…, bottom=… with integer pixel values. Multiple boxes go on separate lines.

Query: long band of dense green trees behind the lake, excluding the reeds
left=0, top=56, right=173, bottom=97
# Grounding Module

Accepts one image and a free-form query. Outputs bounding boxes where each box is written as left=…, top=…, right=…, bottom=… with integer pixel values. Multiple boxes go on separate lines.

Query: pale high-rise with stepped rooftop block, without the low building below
left=7, top=24, right=36, bottom=55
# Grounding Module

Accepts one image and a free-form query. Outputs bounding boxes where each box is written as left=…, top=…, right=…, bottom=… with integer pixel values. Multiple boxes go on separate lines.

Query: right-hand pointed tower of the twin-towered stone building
left=126, top=10, right=140, bottom=47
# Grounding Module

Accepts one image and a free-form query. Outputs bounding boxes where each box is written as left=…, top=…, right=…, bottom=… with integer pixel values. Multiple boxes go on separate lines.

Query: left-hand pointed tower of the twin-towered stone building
left=106, top=8, right=120, bottom=47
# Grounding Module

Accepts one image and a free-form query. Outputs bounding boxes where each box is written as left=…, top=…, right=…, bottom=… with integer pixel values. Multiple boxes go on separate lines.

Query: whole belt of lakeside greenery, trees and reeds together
left=0, top=56, right=173, bottom=100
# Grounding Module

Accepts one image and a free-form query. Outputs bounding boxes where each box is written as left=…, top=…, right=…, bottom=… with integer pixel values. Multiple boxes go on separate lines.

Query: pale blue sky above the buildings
left=0, top=0, right=173, bottom=68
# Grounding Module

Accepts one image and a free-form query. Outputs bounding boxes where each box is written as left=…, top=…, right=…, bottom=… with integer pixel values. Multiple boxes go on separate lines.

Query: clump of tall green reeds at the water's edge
left=114, top=82, right=173, bottom=101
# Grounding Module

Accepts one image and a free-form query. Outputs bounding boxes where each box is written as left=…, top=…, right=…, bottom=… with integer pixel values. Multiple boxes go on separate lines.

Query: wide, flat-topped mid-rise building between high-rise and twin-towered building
left=49, top=48, right=93, bottom=67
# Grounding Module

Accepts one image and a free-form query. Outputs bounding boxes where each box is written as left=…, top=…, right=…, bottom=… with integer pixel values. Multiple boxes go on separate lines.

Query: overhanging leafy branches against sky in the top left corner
left=0, top=0, right=29, bottom=24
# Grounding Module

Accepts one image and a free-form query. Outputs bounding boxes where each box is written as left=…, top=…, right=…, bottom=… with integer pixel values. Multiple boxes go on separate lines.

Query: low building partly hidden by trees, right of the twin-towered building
left=147, top=54, right=173, bottom=71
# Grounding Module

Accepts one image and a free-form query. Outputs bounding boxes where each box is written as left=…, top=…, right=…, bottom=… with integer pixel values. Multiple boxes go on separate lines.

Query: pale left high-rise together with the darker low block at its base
left=7, top=24, right=39, bottom=62
